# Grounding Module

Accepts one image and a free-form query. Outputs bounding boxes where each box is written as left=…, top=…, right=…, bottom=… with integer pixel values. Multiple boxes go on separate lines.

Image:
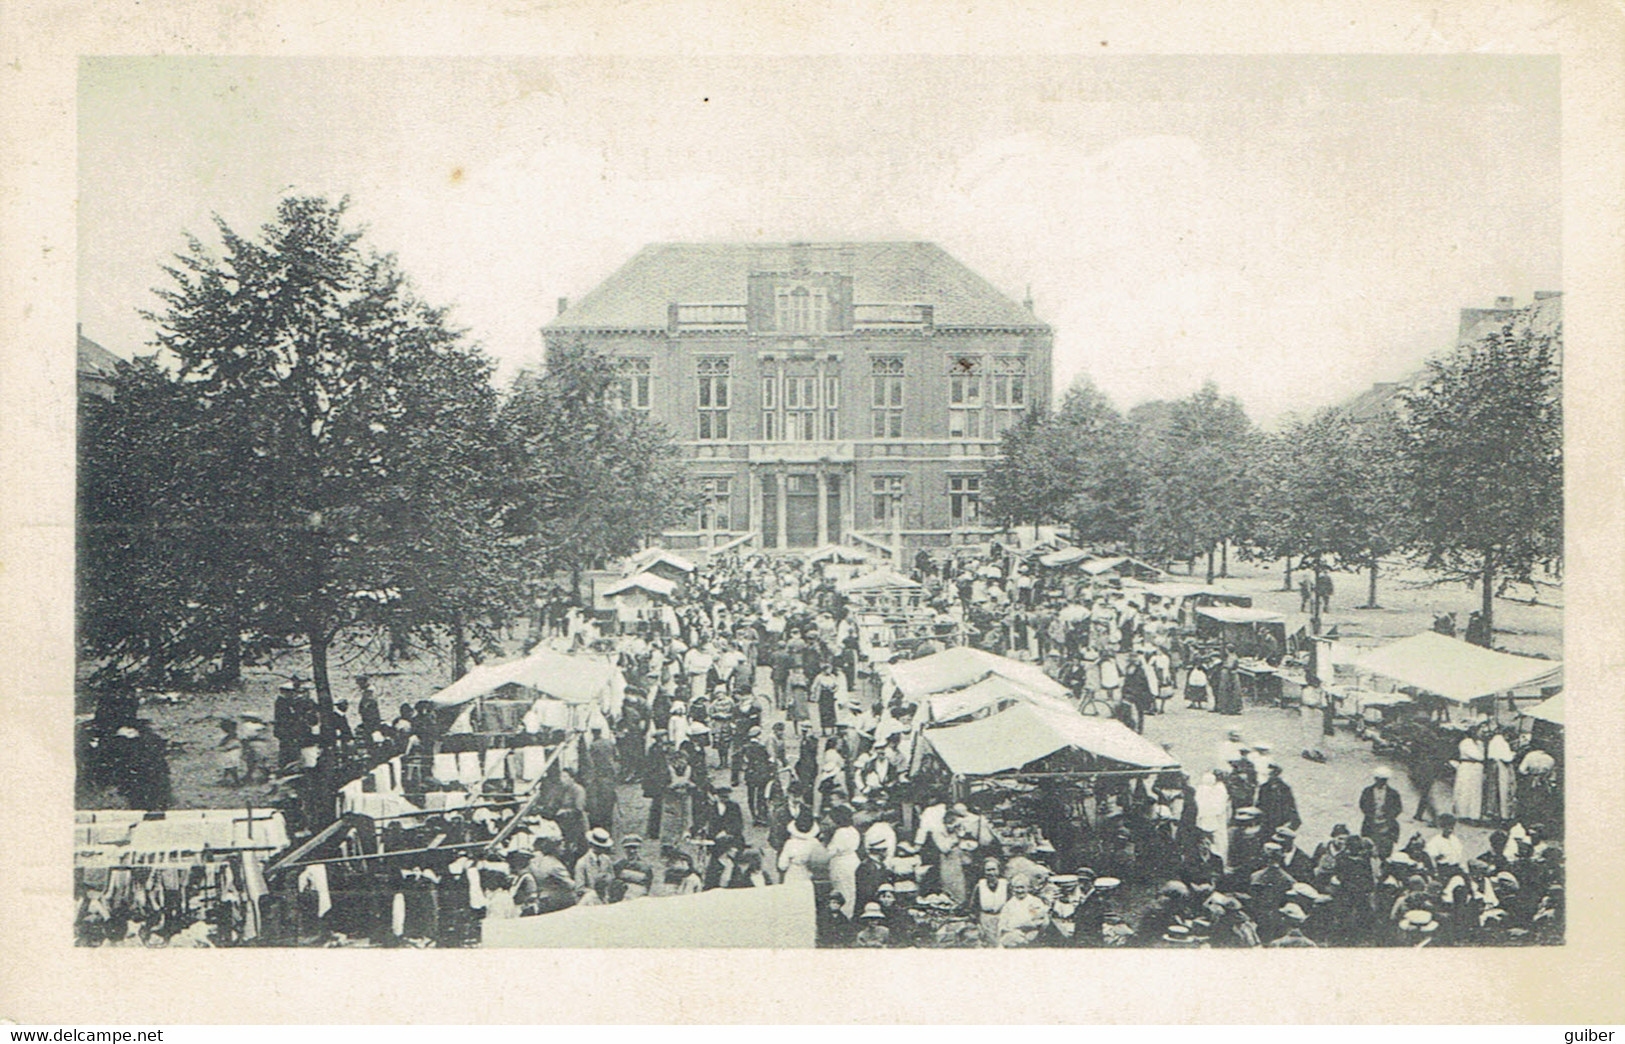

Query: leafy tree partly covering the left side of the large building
left=501, top=341, right=697, bottom=588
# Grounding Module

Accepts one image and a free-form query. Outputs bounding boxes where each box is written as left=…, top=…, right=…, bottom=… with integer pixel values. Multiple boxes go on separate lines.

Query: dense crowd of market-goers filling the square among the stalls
left=73, top=546, right=1563, bottom=946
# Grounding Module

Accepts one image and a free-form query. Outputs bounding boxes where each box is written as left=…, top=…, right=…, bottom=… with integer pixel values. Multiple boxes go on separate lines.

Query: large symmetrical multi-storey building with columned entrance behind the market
left=543, top=242, right=1051, bottom=548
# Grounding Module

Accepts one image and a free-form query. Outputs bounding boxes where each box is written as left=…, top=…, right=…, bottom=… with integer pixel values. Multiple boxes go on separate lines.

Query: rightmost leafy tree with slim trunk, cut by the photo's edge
left=1399, top=320, right=1563, bottom=636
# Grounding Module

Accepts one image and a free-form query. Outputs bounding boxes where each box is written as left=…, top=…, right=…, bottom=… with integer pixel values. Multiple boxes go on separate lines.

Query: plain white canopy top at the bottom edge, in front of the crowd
left=481, top=881, right=817, bottom=950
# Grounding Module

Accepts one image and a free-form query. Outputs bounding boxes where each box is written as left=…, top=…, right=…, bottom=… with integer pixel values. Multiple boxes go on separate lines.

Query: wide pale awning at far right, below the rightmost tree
left=1359, top=631, right=1563, bottom=703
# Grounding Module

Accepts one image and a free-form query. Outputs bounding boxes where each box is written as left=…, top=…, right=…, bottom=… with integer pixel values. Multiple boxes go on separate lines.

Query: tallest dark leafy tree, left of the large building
left=137, top=197, right=504, bottom=715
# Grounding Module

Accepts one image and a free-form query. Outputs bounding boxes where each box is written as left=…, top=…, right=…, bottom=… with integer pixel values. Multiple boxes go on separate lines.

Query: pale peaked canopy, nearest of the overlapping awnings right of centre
left=925, top=703, right=1180, bottom=776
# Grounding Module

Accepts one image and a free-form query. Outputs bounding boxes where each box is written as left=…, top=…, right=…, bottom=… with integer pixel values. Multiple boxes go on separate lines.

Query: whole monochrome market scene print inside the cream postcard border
left=62, top=52, right=1578, bottom=949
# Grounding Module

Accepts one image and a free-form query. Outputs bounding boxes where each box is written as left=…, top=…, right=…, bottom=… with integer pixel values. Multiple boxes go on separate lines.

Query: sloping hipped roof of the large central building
left=548, top=242, right=1043, bottom=330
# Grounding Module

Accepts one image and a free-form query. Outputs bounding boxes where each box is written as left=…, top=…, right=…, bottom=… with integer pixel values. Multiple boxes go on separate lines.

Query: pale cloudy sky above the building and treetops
left=78, top=55, right=1562, bottom=424
